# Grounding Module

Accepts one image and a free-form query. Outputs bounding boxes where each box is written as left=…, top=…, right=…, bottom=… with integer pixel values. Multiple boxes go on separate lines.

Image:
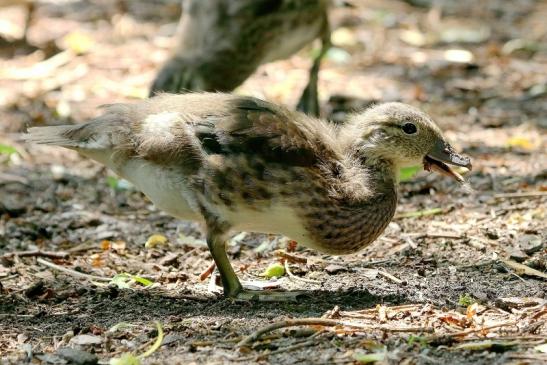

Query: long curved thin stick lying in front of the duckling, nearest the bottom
left=236, top=318, right=433, bottom=348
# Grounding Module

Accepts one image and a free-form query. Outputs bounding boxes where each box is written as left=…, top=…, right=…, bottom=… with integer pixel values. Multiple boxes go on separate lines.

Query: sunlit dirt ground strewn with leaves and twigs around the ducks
left=0, top=0, right=547, bottom=365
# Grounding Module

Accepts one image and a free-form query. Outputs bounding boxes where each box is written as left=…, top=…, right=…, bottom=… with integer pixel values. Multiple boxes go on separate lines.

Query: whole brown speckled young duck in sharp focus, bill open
left=28, top=93, right=471, bottom=299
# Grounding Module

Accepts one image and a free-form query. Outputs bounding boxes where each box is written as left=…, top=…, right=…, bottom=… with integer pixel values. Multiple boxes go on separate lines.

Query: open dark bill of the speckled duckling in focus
left=424, top=141, right=471, bottom=183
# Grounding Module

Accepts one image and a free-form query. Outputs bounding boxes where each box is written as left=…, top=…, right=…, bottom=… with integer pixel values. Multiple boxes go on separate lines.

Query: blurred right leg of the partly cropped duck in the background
left=296, top=13, right=331, bottom=117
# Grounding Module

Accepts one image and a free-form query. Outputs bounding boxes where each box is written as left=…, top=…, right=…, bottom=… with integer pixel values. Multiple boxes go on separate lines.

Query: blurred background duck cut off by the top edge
left=150, top=0, right=330, bottom=115
